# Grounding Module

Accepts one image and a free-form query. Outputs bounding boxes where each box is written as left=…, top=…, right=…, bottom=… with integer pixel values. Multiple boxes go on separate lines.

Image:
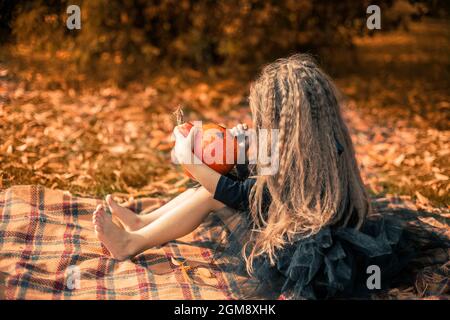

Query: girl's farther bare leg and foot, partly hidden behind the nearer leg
left=106, top=189, right=196, bottom=231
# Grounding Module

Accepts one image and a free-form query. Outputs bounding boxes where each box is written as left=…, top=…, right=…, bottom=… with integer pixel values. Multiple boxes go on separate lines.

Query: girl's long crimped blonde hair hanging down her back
left=244, top=54, right=370, bottom=273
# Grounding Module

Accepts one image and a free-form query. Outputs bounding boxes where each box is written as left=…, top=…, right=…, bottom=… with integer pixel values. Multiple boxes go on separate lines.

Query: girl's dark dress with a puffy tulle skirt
left=214, top=166, right=450, bottom=299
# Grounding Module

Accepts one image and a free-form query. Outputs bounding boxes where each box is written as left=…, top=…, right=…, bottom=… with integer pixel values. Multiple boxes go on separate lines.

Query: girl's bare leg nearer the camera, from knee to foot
left=93, top=187, right=224, bottom=260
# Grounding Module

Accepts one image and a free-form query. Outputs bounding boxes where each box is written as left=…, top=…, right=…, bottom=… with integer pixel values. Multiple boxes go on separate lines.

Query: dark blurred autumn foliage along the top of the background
left=0, top=0, right=449, bottom=84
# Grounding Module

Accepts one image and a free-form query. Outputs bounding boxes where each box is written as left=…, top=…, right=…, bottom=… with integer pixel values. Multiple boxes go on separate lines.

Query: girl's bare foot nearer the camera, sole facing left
left=92, top=205, right=134, bottom=261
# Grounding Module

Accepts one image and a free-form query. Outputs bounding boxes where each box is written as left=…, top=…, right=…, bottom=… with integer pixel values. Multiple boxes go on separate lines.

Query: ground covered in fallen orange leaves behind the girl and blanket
left=0, top=22, right=450, bottom=212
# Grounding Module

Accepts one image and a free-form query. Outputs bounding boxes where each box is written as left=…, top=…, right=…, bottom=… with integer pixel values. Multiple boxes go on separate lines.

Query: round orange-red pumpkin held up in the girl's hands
left=178, top=122, right=238, bottom=178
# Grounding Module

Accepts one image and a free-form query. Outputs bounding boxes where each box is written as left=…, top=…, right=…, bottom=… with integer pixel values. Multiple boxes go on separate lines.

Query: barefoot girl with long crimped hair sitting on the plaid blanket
left=93, top=55, right=418, bottom=298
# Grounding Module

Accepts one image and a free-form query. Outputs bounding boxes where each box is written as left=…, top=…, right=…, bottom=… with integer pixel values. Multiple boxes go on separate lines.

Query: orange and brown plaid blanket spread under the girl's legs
left=0, top=186, right=248, bottom=299
